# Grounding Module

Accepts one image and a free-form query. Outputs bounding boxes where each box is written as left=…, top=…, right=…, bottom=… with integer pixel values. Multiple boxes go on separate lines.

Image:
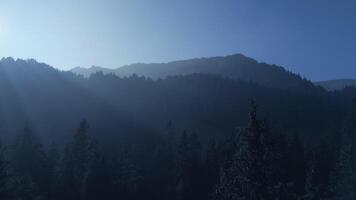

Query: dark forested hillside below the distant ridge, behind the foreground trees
left=0, top=58, right=353, bottom=144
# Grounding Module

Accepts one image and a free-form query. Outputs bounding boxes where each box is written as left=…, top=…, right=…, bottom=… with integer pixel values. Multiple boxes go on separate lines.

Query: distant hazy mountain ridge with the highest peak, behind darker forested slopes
left=71, top=54, right=313, bottom=90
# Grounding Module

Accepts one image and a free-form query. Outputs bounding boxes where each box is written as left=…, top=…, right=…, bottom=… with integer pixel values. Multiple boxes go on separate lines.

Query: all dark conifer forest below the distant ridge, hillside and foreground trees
left=0, top=55, right=356, bottom=200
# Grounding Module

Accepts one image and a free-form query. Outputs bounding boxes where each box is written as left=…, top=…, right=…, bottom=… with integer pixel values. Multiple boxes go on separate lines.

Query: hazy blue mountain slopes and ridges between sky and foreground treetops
left=0, top=54, right=353, bottom=144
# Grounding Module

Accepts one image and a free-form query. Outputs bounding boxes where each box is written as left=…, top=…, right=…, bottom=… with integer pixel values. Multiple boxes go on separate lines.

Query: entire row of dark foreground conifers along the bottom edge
left=0, top=103, right=356, bottom=200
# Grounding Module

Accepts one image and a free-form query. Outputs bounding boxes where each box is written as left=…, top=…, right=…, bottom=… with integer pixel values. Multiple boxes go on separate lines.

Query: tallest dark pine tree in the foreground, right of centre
left=215, top=102, right=286, bottom=200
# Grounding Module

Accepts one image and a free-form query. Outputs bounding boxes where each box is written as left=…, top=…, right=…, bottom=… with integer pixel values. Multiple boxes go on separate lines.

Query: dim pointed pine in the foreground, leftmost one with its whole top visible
left=10, top=125, right=50, bottom=199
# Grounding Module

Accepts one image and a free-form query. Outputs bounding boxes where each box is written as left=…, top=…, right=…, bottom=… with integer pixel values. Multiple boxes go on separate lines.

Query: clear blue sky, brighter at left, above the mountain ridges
left=0, top=0, right=356, bottom=80
